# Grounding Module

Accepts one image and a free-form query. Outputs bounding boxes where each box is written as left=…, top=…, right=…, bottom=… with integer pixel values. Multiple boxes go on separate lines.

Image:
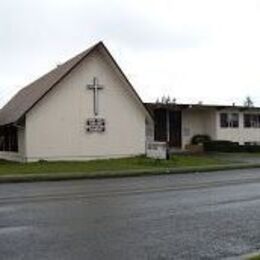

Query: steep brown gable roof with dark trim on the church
left=0, top=42, right=150, bottom=125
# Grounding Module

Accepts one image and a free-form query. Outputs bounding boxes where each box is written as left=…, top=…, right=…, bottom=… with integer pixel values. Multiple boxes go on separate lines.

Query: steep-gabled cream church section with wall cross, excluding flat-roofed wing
left=0, top=42, right=153, bottom=162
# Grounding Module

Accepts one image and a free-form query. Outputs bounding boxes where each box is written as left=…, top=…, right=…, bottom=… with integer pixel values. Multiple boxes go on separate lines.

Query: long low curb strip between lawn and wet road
left=0, top=163, right=260, bottom=183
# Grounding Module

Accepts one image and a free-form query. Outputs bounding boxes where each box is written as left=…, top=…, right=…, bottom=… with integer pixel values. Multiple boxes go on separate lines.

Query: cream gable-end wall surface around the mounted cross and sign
left=25, top=51, right=150, bottom=161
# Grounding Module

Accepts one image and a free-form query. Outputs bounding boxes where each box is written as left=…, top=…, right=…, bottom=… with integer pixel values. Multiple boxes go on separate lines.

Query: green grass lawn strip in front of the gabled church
left=0, top=155, right=230, bottom=176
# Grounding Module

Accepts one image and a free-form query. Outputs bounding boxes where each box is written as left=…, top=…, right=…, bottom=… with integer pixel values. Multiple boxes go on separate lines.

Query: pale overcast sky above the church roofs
left=0, top=0, right=260, bottom=106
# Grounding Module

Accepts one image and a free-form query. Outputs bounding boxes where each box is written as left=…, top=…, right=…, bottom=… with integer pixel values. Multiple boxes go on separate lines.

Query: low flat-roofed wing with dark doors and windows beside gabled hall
left=146, top=103, right=260, bottom=149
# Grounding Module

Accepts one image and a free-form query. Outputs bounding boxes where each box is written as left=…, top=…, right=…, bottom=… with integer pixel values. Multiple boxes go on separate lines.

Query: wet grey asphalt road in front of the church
left=0, top=170, right=260, bottom=260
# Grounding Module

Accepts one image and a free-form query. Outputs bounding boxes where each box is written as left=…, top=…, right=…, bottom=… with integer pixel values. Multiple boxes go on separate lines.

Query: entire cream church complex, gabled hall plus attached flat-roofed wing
left=0, top=42, right=260, bottom=162
